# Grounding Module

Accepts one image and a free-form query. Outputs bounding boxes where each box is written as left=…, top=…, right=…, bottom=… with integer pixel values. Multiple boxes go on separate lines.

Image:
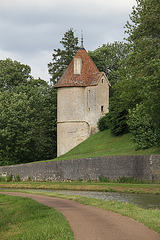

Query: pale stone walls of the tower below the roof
left=57, top=76, right=109, bottom=156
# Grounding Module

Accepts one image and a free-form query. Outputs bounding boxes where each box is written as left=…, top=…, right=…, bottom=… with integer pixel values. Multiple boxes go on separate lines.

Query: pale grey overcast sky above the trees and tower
left=0, top=0, right=136, bottom=80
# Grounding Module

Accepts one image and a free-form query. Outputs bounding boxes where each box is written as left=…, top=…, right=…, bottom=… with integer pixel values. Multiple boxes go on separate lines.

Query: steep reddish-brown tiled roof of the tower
left=55, top=48, right=109, bottom=88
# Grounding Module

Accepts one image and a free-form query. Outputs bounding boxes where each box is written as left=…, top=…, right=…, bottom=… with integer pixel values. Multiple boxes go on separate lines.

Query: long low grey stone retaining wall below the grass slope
left=0, top=155, right=160, bottom=181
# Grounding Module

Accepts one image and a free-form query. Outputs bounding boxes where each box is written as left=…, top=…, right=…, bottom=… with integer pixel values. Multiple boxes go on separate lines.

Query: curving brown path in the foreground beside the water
left=1, top=192, right=160, bottom=240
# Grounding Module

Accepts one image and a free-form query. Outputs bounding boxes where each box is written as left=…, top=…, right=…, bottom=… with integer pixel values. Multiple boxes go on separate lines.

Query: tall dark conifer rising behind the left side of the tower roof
left=48, top=28, right=78, bottom=84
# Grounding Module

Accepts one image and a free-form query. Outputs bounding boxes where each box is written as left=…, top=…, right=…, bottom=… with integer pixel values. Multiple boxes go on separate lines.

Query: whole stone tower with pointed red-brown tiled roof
left=55, top=45, right=110, bottom=156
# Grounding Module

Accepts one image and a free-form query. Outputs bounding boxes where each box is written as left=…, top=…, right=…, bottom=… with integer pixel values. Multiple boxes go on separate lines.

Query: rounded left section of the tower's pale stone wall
left=57, top=87, right=89, bottom=156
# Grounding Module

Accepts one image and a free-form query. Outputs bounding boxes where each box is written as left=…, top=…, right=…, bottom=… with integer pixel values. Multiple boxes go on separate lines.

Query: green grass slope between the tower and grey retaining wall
left=54, top=130, right=160, bottom=161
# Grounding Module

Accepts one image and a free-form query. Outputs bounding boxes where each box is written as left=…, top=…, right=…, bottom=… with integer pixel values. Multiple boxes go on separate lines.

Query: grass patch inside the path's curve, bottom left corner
left=0, top=194, right=74, bottom=240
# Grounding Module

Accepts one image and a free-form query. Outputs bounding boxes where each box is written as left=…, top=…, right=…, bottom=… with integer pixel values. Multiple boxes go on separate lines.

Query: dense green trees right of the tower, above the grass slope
left=99, top=0, right=160, bottom=148
